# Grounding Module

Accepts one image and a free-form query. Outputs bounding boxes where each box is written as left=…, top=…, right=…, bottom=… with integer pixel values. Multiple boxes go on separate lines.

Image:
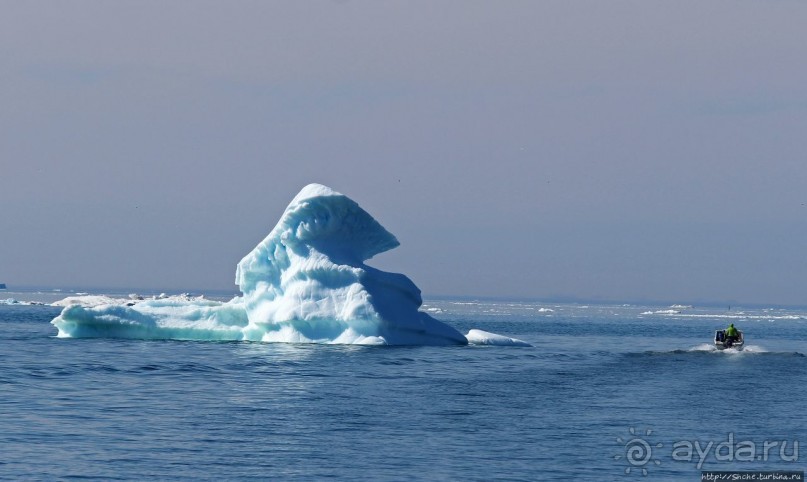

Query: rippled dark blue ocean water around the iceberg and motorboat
left=0, top=292, right=807, bottom=481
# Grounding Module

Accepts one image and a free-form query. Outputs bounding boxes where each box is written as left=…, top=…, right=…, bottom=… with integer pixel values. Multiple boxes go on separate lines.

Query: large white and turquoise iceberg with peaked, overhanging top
left=52, top=184, right=523, bottom=345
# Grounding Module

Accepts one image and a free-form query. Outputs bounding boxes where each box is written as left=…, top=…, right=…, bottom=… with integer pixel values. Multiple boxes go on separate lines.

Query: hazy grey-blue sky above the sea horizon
left=0, top=0, right=807, bottom=304
